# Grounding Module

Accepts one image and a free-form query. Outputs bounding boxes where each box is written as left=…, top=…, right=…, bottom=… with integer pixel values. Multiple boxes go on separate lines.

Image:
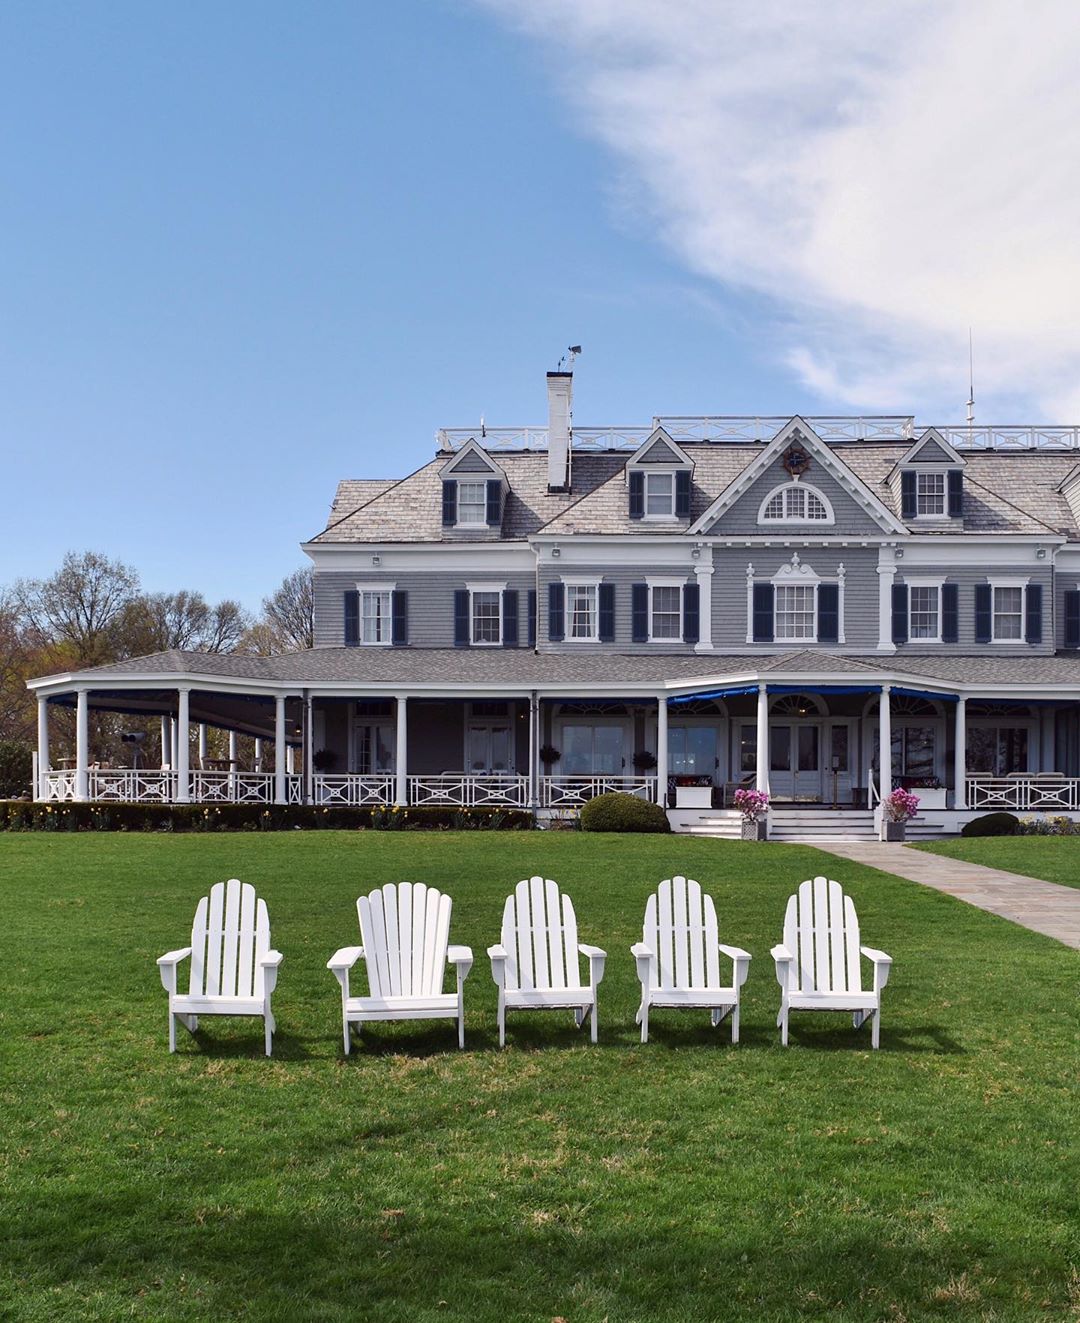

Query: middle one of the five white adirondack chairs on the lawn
left=487, top=877, right=608, bottom=1048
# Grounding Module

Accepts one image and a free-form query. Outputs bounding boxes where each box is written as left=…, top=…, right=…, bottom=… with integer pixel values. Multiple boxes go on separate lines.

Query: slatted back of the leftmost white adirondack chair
left=189, top=877, right=270, bottom=998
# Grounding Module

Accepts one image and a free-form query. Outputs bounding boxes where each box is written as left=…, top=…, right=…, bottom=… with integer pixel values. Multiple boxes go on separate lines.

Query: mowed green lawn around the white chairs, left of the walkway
left=0, top=832, right=1080, bottom=1323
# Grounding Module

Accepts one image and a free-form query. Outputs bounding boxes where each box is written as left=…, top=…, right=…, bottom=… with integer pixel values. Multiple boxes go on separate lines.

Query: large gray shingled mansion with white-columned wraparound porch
left=30, top=372, right=1080, bottom=835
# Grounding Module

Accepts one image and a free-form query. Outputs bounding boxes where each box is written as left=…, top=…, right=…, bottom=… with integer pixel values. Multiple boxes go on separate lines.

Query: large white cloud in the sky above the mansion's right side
left=479, top=0, right=1080, bottom=421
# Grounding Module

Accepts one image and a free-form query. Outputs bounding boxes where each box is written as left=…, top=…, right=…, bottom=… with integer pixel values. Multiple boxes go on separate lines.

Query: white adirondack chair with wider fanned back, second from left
left=327, top=882, right=473, bottom=1054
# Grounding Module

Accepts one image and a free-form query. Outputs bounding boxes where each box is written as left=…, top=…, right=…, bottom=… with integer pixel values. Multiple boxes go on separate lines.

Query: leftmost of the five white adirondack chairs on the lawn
left=158, top=877, right=282, bottom=1057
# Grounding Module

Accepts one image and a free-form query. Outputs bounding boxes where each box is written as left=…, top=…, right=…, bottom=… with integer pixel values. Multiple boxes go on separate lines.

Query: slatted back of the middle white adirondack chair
left=500, top=877, right=582, bottom=992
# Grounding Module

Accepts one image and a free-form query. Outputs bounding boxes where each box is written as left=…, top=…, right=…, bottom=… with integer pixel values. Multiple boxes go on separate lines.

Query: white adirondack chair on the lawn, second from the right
left=630, top=877, right=750, bottom=1043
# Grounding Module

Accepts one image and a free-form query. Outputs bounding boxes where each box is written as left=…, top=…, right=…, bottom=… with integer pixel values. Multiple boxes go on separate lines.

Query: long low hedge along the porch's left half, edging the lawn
left=0, top=799, right=533, bottom=832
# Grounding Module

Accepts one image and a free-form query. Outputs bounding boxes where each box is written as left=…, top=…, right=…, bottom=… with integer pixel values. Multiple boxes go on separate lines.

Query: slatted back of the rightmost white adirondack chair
left=784, top=877, right=863, bottom=992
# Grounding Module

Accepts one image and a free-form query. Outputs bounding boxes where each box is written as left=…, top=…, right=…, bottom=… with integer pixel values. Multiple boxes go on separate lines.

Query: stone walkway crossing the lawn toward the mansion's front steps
left=818, top=841, right=1080, bottom=950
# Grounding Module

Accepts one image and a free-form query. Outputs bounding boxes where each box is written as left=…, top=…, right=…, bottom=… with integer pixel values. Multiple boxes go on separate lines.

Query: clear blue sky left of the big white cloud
left=0, top=0, right=1080, bottom=607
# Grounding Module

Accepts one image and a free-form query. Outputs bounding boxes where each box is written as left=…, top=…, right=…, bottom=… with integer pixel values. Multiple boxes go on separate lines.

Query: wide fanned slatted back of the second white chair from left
left=356, top=882, right=451, bottom=996
